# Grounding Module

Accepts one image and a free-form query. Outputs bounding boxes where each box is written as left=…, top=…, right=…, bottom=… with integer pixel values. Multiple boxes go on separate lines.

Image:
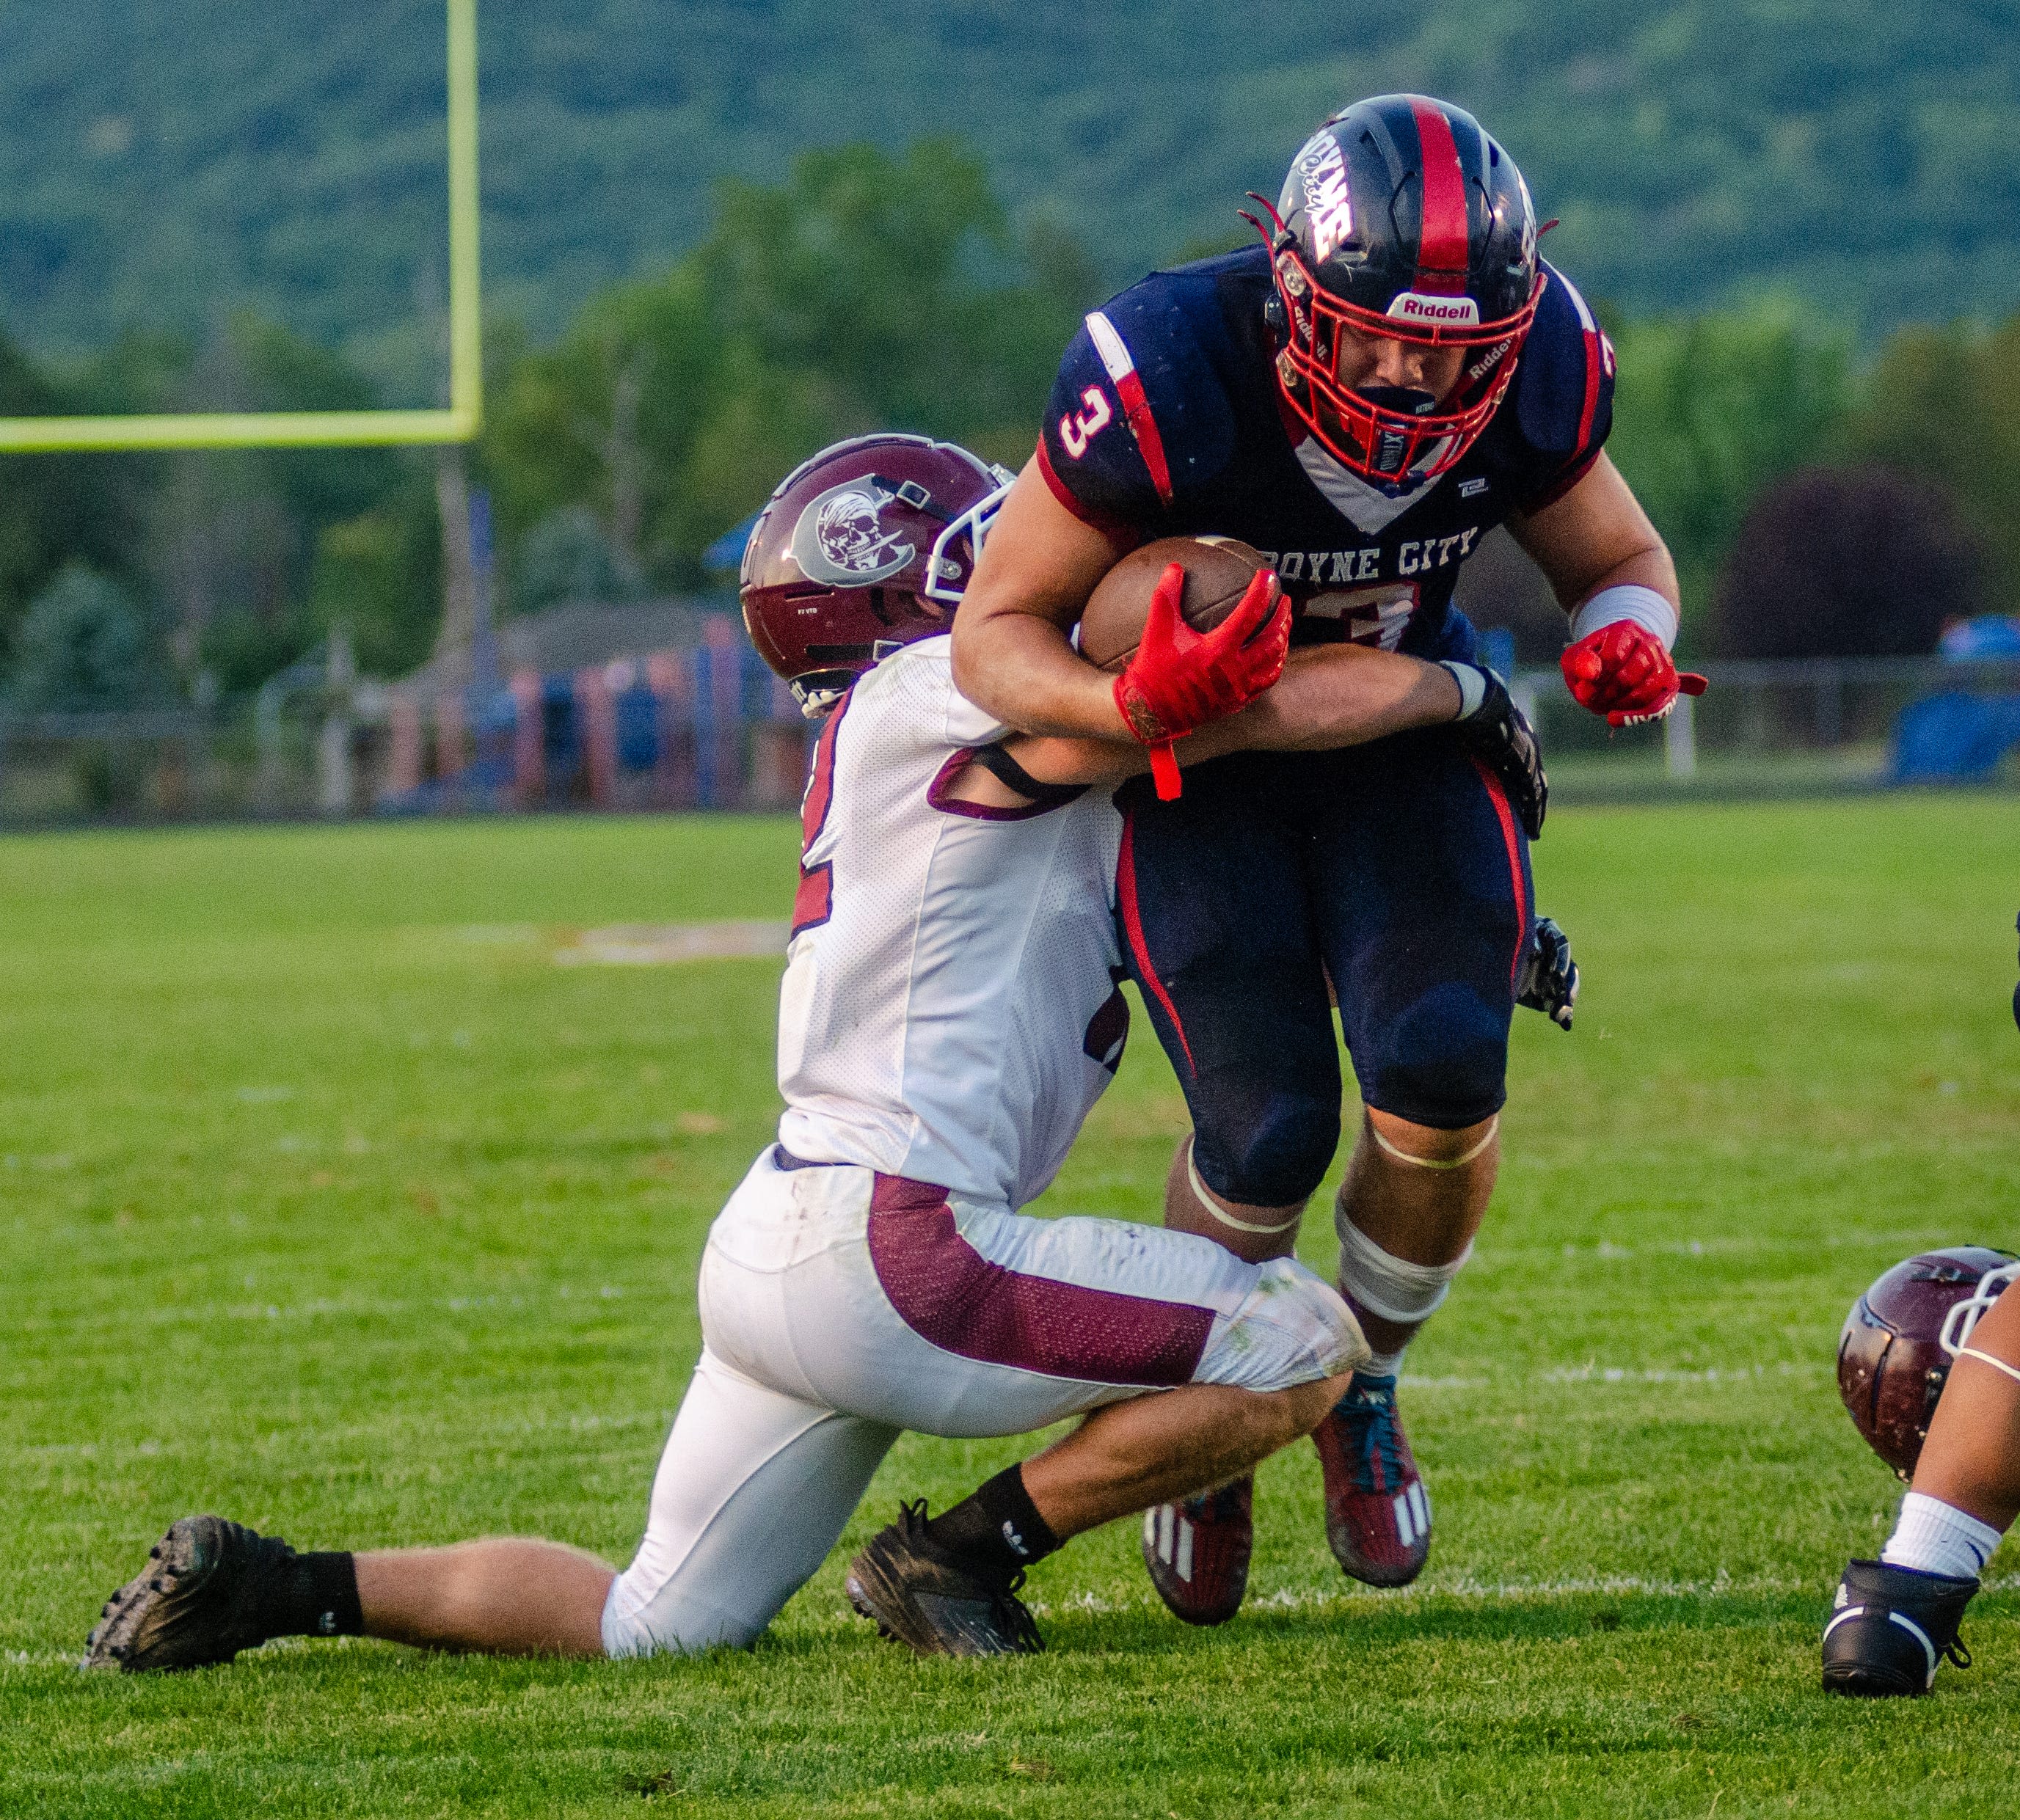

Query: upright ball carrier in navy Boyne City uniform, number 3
left=953, top=95, right=1703, bottom=1624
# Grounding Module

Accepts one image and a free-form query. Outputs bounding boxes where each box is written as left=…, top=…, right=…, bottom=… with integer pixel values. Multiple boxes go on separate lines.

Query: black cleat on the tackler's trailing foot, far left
left=83, top=1517, right=295, bottom=1675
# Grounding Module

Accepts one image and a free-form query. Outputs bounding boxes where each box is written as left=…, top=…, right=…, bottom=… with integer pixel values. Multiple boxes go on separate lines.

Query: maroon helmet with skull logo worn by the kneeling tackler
left=737, top=434, right=1012, bottom=719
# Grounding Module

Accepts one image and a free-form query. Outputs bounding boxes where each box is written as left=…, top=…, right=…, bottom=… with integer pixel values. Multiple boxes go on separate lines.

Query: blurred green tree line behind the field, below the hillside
left=0, top=139, right=2020, bottom=711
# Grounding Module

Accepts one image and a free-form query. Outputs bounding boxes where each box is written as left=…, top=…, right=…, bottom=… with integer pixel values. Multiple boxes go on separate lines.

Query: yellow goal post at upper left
left=0, top=0, right=485, bottom=455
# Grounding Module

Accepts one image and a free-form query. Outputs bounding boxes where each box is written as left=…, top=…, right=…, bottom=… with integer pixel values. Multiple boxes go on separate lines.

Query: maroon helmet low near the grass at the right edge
left=1838, top=1244, right=2014, bottom=1479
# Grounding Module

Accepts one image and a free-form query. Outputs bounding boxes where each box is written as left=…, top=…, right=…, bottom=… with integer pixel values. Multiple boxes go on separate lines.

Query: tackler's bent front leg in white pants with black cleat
left=784, top=1172, right=1365, bottom=1654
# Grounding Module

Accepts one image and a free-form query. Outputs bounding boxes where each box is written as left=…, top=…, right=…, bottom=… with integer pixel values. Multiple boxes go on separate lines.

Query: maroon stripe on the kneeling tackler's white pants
left=871, top=1176, right=1214, bottom=1384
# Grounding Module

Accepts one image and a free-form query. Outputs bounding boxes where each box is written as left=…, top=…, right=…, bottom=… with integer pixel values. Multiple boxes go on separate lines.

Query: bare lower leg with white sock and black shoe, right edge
left=1824, top=1289, right=2020, bottom=1697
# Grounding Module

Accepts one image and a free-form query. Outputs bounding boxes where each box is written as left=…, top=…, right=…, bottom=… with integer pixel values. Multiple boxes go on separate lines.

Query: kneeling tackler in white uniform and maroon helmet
left=74, top=436, right=1539, bottom=1670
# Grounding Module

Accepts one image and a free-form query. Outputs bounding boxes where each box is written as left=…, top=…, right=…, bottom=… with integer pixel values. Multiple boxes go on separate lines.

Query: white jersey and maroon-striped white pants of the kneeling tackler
left=604, top=636, right=1365, bottom=1656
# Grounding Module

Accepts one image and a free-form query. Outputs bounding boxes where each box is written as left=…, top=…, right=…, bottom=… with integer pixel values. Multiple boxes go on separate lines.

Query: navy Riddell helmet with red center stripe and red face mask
left=1248, top=95, right=1543, bottom=485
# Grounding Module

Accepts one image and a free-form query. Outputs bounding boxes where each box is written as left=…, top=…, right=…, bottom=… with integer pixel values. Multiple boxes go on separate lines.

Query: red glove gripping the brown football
left=1115, top=562, right=1291, bottom=802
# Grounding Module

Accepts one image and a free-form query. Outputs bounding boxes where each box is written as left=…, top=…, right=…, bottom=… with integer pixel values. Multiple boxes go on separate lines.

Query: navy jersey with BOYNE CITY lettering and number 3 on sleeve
left=1038, top=246, right=1614, bottom=654
